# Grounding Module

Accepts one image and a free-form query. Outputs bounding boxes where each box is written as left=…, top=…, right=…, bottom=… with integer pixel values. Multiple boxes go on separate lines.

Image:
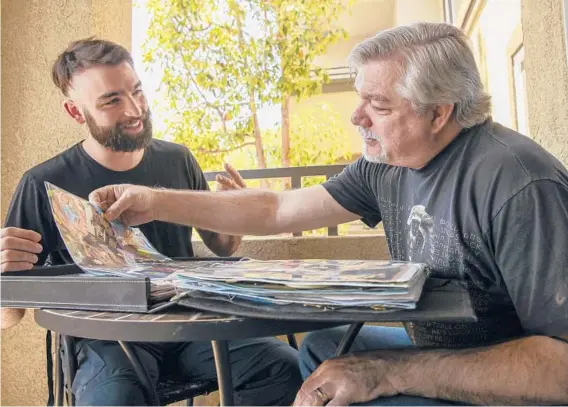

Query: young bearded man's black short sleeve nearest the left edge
left=4, top=174, right=58, bottom=265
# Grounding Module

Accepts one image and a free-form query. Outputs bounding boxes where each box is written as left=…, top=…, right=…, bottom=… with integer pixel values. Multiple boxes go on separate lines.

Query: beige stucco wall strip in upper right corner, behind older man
left=521, top=0, right=568, bottom=165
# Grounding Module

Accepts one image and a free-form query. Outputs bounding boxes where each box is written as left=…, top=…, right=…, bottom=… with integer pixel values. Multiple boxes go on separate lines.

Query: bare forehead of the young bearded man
left=69, top=62, right=140, bottom=102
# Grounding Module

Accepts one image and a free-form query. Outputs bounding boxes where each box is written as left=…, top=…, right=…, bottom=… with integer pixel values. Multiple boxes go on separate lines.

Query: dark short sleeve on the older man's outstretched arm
left=322, top=158, right=382, bottom=227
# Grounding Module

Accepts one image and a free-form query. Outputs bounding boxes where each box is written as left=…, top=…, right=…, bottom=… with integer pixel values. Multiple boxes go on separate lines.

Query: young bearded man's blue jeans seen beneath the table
left=63, top=338, right=302, bottom=406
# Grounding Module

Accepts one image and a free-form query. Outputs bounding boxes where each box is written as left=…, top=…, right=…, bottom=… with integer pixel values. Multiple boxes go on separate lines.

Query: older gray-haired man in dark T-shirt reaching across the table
left=91, top=23, right=568, bottom=405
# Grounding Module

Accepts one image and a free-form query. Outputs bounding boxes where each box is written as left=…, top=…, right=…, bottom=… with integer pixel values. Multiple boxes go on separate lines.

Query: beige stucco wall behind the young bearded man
left=0, top=0, right=132, bottom=405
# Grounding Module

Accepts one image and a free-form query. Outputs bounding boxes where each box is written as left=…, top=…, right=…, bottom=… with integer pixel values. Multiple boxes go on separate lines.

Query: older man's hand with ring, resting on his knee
left=294, top=354, right=398, bottom=406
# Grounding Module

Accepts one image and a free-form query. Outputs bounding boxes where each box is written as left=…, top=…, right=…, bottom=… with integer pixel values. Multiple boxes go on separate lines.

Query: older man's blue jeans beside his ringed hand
left=300, top=326, right=464, bottom=406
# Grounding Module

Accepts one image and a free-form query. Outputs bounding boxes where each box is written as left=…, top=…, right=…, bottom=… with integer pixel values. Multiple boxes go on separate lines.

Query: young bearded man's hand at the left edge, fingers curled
left=0, top=227, right=43, bottom=273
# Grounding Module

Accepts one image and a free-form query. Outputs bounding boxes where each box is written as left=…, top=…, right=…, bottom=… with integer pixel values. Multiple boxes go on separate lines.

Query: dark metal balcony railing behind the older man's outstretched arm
left=205, top=164, right=345, bottom=236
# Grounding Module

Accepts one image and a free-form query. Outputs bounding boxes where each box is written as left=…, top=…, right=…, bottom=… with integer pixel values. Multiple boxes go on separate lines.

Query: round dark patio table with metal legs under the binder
left=35, top=307, right=344, bottom=405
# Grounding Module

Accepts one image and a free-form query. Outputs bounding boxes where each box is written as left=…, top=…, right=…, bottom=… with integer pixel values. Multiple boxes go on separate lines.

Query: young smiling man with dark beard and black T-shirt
left=1, top=39, right=301, bottom=405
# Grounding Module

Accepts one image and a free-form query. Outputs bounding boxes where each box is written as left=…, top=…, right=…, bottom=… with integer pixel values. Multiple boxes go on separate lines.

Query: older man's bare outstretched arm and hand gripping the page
left=90, top=185, right=359, bottom=235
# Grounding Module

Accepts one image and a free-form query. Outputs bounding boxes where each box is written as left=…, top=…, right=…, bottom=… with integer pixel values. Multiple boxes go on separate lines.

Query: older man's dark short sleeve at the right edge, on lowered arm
left=490, top=180, right=568, bottom=336
